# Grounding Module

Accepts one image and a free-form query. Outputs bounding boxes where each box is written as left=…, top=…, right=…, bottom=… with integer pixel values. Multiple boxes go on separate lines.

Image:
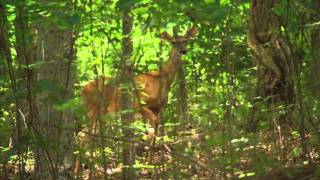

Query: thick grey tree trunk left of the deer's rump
left=35, top=1, right=75, bottom=179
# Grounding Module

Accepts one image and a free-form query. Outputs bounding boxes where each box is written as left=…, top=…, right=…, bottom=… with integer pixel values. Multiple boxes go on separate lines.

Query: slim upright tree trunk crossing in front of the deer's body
left=120, top=8, right=136, bottom=180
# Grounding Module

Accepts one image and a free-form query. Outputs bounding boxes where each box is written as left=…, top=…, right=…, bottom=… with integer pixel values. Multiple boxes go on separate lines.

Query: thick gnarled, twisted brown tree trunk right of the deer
left=248, top=0, right=294, bottom=130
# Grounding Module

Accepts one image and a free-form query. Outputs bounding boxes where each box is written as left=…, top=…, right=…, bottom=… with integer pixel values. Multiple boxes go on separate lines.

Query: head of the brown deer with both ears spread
left=160, top=26, right=197, bottom=55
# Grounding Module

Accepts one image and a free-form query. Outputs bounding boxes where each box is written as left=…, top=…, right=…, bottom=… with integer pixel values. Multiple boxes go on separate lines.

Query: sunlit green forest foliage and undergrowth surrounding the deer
left=0, top=0, right=320, bottom=179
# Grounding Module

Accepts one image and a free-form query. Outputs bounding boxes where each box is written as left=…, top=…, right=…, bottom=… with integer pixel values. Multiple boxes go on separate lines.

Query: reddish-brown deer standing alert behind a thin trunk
left=76, top=26, right=197, bottom=174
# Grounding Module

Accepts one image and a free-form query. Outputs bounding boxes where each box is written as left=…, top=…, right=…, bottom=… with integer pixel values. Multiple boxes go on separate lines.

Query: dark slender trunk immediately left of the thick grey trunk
left=14, top=1, right=37, bottom=131
